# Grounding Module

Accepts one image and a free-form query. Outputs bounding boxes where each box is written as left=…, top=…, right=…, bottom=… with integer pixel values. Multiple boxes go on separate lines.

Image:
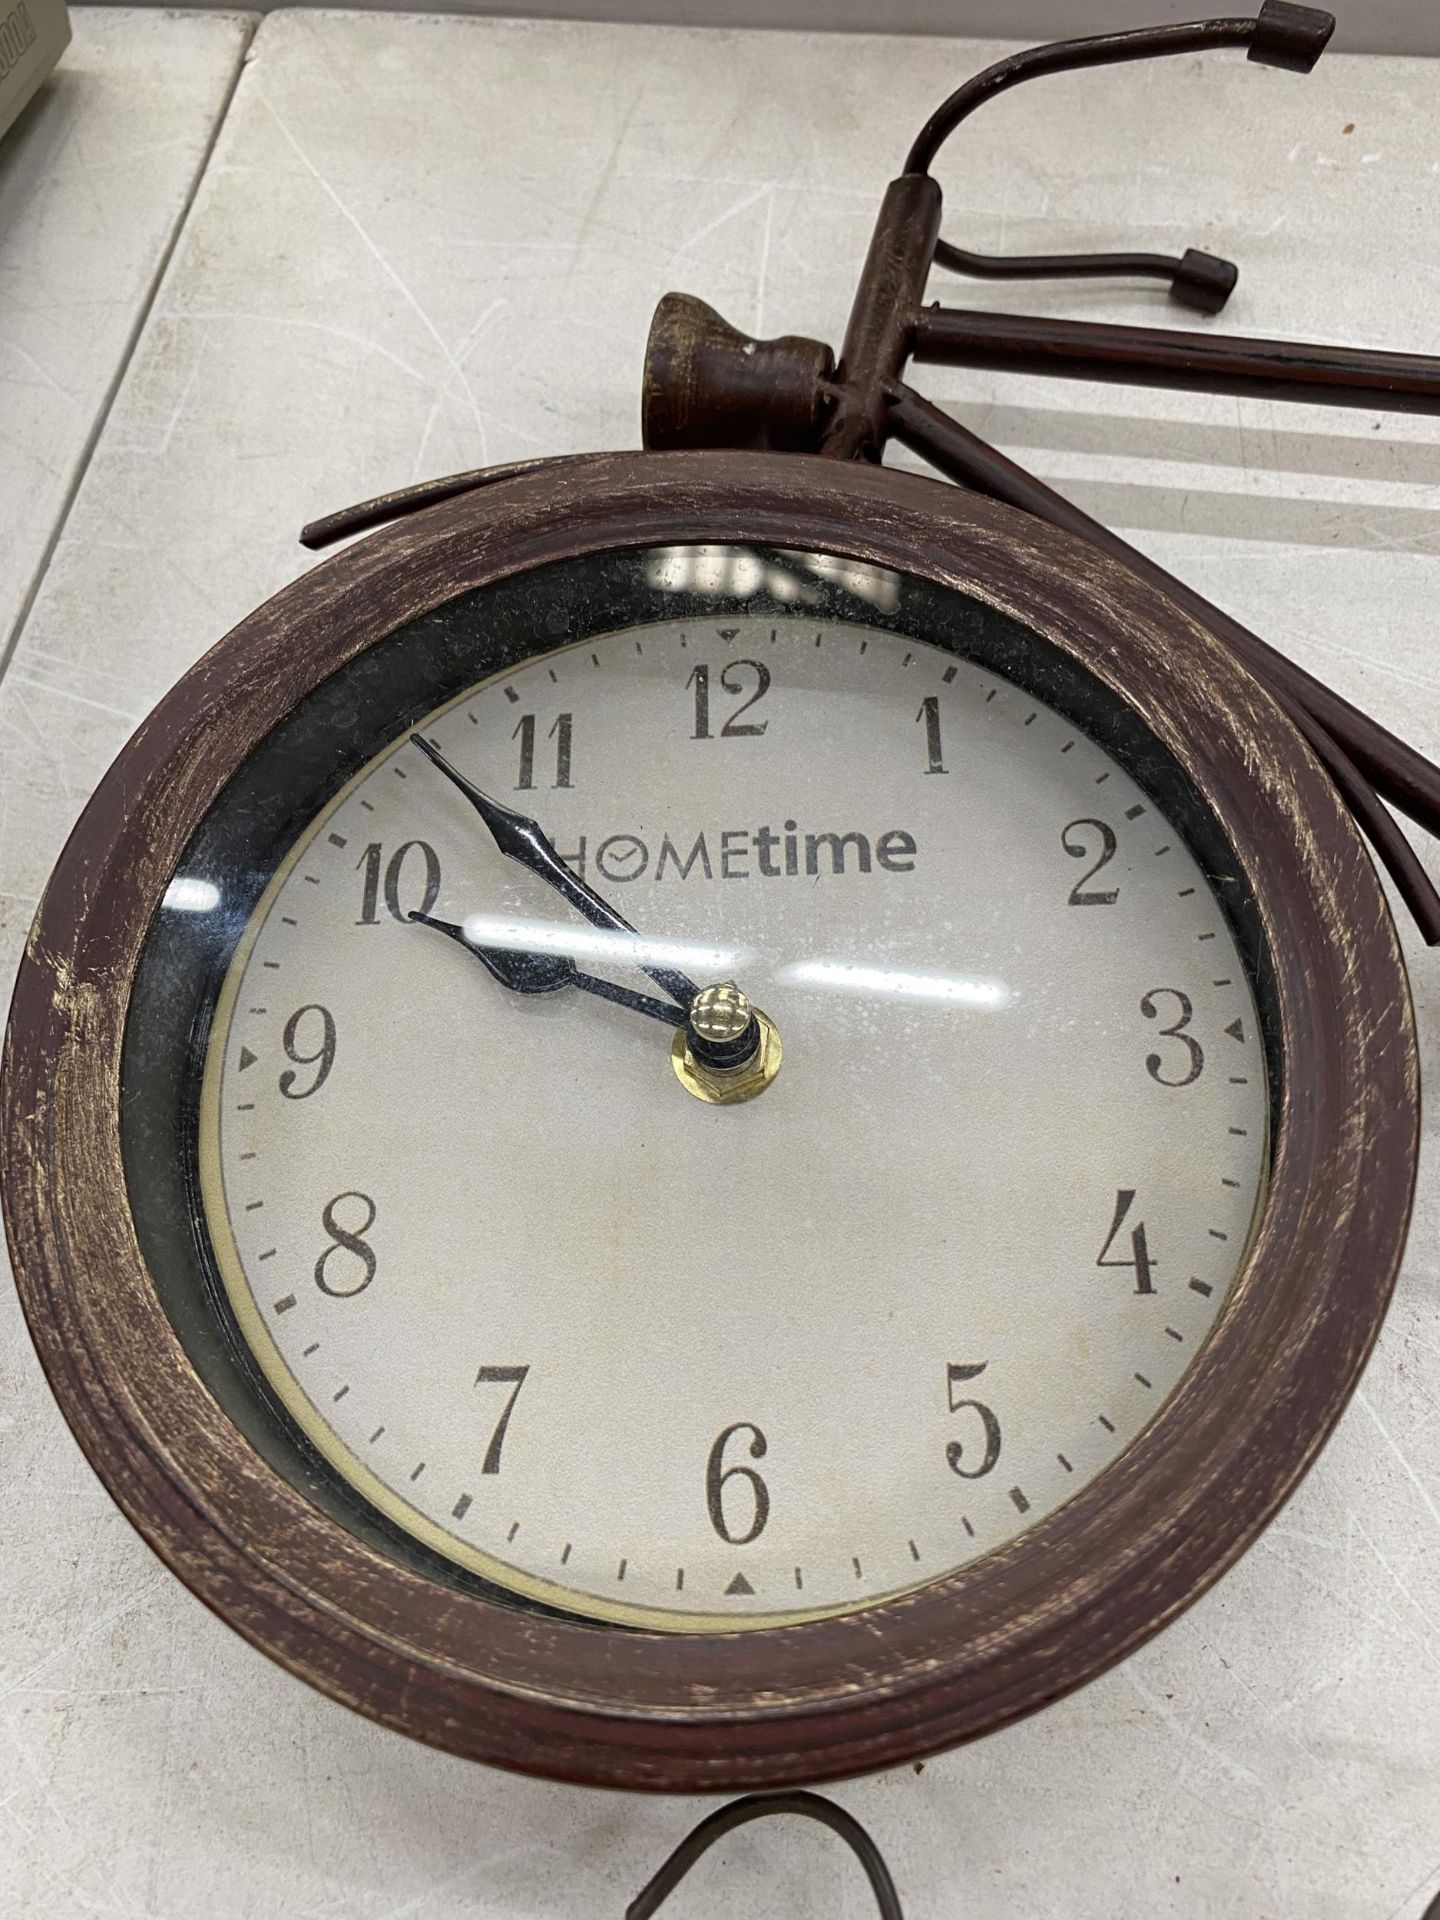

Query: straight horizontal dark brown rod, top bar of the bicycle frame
left=912, top=307, right=1440, bottom=413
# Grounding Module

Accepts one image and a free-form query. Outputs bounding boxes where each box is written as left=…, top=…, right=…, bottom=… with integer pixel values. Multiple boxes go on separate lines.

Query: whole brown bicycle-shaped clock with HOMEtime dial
left=4, top=6, right=1440, bottom=1789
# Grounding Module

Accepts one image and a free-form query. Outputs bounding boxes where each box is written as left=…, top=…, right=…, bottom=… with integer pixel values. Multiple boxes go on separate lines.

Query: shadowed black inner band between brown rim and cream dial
left=121, top=545, right=1283, bottom=1630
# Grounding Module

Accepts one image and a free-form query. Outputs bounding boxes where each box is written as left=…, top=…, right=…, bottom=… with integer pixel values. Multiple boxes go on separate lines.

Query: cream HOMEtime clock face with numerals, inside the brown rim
left=129, top=549, right=1271, bottom=1632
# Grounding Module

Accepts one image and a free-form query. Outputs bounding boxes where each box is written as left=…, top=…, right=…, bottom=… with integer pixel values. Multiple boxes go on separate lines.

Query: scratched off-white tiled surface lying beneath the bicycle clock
left=0, top=12, right=1440, bottom=1920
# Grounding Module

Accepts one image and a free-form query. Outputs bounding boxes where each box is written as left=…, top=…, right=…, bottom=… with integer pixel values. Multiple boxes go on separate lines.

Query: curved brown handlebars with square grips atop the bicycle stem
left=904, top=0, right=1334, bottom=313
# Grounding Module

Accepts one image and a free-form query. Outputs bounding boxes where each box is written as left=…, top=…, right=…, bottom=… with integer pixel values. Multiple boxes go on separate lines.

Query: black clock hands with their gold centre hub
left=409, top=733, right=780, bottom=1106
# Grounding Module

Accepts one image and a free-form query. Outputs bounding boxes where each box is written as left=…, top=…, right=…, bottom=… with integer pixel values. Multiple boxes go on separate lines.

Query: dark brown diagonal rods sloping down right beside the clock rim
left=889, top=382, right=1440, bottom=947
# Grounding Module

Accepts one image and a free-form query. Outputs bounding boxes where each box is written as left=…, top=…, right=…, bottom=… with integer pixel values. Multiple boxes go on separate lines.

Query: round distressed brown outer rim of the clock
left=0, top=453, right=1419, bottom=1791
